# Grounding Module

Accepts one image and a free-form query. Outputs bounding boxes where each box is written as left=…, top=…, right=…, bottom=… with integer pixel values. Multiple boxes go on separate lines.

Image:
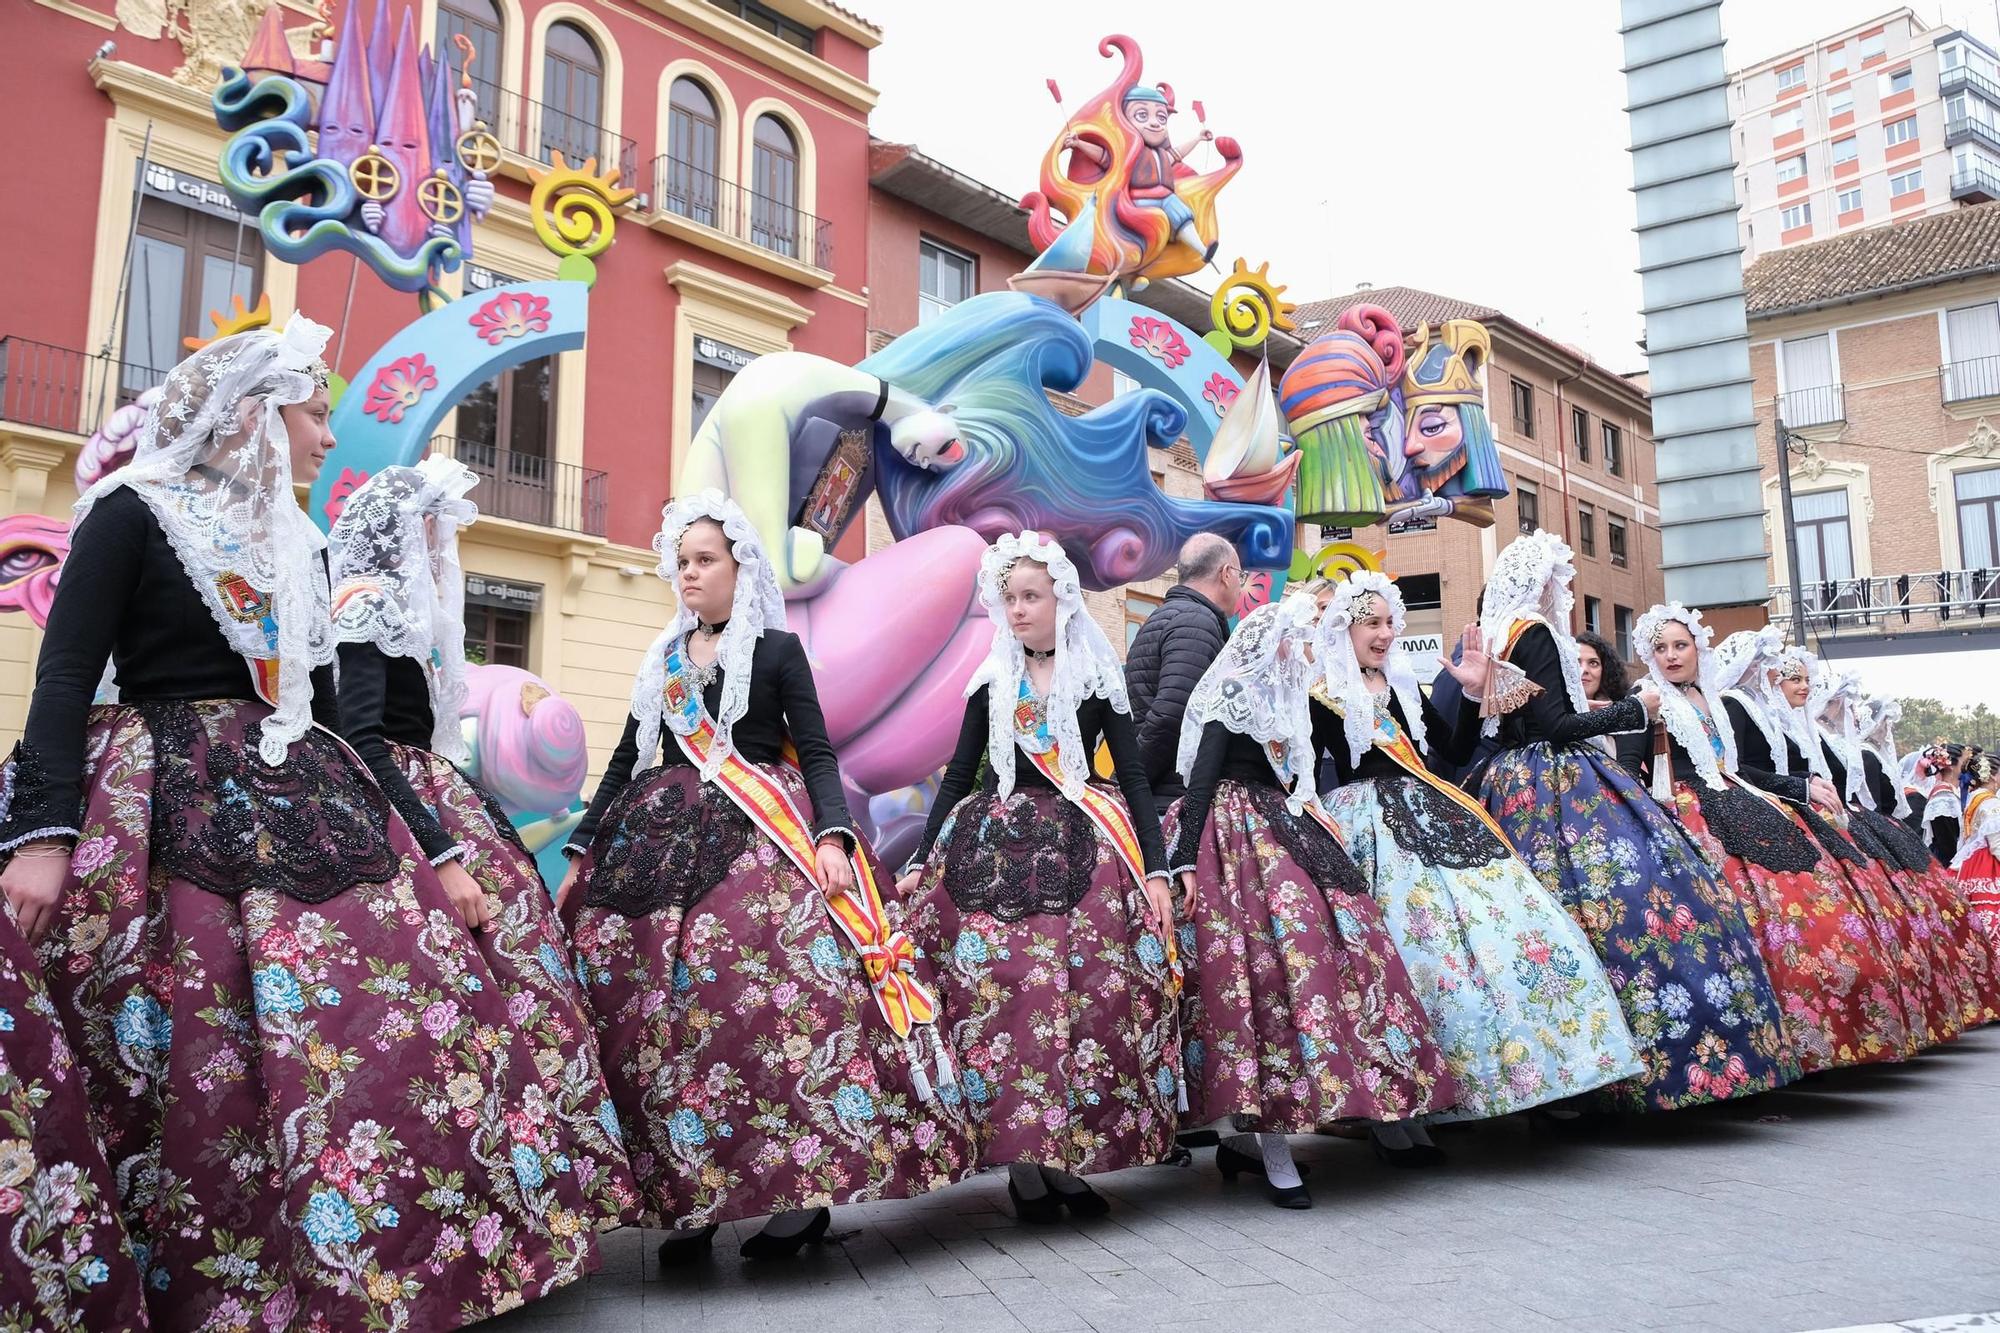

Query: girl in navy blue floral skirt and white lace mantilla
left=1480, top=530, right=1798, bottom=1109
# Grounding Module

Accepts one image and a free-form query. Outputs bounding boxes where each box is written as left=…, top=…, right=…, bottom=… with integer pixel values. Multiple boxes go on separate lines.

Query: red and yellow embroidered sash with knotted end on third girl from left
left=666, top=646, right=938, bottom=1037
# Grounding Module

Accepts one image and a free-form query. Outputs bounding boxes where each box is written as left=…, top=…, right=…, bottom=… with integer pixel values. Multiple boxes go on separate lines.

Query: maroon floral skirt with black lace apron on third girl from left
left=564, top=765, right=972, bottom=1229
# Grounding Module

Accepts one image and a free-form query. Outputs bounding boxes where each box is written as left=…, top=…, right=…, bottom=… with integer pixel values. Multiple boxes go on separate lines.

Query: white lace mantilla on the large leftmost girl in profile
left=70, top=314, right=336, bottom=765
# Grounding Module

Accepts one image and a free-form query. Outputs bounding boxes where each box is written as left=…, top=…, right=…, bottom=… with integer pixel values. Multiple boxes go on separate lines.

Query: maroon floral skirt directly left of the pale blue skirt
left=1166, top=779, right=1460, bottom=1133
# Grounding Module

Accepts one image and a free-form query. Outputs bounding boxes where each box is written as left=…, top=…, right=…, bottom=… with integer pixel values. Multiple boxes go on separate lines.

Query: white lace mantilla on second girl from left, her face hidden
left=330, top=454, right=480, bottom=765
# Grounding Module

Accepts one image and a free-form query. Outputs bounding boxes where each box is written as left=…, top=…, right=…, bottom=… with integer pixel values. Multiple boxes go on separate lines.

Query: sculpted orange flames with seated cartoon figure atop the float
left=1020, top=34, right=1242, bottom=288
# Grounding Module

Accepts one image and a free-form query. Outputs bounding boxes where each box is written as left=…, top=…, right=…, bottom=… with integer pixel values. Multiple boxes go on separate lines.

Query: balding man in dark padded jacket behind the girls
left=1126, top=532, right=1244, bottom=811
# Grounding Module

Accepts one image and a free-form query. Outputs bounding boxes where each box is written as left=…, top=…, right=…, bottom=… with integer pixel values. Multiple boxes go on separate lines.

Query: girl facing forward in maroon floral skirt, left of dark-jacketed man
left=898, top=532, right=1182, bottom=1221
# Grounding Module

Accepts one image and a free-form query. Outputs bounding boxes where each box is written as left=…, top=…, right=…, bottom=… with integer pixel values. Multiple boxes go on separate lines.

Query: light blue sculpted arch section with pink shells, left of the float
left=306, top=280, right=590, bottom=528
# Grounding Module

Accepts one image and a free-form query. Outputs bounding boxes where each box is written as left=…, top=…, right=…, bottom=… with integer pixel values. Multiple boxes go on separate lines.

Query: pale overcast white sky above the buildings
left=864, top=0, right=2000, bottom=705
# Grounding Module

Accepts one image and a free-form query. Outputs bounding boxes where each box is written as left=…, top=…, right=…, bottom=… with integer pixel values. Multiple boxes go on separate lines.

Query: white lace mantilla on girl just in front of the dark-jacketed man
left=1174, top=596, right=1320, bottom=815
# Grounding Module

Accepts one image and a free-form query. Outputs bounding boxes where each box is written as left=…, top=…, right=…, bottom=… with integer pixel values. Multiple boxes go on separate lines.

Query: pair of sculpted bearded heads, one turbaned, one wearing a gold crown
left=1278, top=306, right=1506, bottom=532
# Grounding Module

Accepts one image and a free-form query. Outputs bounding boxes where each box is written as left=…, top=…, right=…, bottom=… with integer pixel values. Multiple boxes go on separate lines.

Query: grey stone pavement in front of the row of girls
left=482, top=1029, right=2000, bottom=1333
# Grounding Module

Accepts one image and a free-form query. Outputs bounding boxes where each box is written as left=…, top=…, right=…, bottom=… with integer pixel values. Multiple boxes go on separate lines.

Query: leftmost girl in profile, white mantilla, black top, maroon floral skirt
left=0, top=314, right=596, bottom=1329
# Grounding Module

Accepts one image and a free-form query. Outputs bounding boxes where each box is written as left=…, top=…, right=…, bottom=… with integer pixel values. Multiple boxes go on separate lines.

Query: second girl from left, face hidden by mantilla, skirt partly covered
left=330, top=456, right=638, bottom=1229
